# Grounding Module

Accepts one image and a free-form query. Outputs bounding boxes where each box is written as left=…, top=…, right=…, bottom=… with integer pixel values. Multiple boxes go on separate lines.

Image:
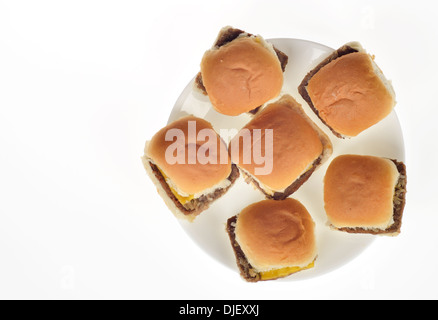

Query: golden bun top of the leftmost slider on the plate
left=145, top=116, right=231, bottom=195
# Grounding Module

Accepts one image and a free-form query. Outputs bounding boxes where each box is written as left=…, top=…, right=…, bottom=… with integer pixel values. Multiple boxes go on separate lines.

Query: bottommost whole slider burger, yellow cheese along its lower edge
left=227, top=198, right=317, bottom=282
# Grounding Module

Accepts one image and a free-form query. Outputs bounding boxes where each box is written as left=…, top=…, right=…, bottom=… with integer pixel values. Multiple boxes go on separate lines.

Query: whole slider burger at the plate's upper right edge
left=298, top=42, right=396, bottom=138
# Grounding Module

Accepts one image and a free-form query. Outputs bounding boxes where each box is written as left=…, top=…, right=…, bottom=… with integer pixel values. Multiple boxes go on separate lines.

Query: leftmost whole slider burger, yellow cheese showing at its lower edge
left=142, top=116, right=239, bottom=221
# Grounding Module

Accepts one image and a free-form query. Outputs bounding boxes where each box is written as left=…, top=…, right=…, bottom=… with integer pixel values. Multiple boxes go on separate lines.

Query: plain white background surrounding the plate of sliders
left=0, top=0, right=438, bottom=299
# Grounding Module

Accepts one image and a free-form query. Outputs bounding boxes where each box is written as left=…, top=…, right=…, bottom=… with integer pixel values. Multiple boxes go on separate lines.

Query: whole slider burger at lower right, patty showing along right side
left=324, top=155, right=406, bottom=236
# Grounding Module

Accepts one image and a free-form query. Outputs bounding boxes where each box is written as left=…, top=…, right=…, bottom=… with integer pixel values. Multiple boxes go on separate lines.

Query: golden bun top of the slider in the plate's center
left=231, top=95, right=324, bottom=192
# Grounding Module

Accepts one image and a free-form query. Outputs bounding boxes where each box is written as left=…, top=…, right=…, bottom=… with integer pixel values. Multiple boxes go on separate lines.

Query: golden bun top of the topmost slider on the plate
left=201, top=36, right=283, bottom=116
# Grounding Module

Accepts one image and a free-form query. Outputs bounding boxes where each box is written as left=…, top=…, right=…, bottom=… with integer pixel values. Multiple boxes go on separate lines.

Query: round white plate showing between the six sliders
left=169, top=39, right=404, bottom=281
